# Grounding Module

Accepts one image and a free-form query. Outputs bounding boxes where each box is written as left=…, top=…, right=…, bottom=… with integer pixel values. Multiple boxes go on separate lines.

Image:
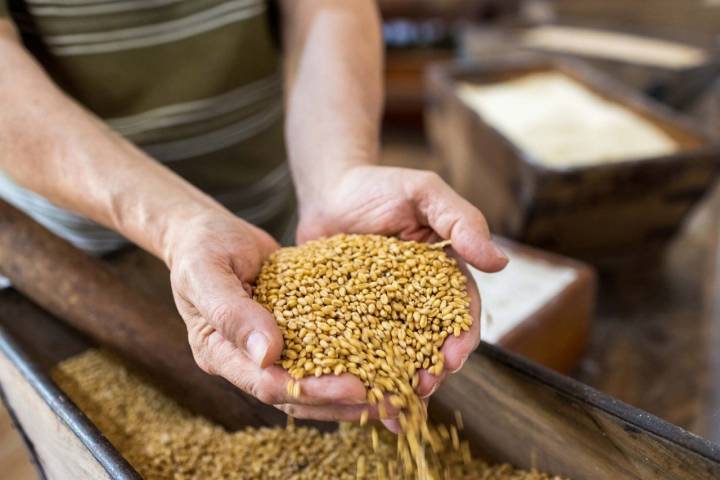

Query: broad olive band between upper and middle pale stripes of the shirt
left=35, top=18, right=278, bottom=118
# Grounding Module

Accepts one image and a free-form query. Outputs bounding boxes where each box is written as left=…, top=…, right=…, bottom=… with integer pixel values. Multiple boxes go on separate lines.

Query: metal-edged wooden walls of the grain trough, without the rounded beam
left=0, top=290, right=720, bottom=480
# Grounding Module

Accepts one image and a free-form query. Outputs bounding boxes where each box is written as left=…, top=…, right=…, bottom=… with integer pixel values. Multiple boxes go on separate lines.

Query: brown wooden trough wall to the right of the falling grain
left=431, top=344, right=720, bottom=480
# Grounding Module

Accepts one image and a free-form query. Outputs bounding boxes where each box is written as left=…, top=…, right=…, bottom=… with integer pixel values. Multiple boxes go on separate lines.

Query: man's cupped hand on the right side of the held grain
left=297, top=166, right=507, bottom=404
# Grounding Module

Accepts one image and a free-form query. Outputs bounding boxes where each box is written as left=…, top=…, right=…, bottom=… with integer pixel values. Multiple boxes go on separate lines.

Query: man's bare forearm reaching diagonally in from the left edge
left=0, top=21, right=221, bottom=259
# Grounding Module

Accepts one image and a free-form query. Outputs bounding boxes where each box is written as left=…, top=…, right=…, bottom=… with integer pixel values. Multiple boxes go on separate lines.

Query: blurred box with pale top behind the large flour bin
left=459, top=23, right=720, bottom=109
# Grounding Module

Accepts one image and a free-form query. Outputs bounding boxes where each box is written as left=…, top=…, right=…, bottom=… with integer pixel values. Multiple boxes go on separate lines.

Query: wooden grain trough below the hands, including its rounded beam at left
left=0, top=202, right=720, bottom=480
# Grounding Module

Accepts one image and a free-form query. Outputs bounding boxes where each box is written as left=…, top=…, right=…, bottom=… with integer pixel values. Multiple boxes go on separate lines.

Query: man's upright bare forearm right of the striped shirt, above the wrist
left=283, top=0, right=383, bottom=214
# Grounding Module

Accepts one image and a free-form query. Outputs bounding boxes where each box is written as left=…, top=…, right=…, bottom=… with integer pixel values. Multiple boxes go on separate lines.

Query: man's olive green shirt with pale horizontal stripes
left=0, top=0, right=294, bottom=252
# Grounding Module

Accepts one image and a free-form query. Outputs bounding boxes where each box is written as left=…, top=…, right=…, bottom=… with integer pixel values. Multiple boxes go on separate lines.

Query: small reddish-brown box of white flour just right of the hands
left=476, top=238, right=596, bottom=373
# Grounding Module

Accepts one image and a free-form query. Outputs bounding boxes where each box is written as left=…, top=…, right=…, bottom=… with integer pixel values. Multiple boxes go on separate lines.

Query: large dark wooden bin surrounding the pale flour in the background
left=426, top=55, right=720, bottom=263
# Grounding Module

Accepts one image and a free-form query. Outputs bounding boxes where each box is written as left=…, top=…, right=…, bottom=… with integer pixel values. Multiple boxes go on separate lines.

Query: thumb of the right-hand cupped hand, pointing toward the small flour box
left=411, top=173, right=508, bottom=272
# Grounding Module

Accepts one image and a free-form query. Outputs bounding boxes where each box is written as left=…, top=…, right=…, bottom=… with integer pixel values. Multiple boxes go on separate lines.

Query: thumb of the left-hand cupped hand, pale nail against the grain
left=184, top=261, right=283, bottom=367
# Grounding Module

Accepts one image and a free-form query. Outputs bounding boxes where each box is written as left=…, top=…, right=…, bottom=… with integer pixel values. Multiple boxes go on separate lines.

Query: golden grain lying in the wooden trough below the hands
left=53, top=350, right=560, bottom=480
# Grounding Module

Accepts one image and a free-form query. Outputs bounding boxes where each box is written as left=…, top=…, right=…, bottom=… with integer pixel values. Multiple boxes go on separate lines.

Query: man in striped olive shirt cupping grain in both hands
left=0, top=0, right=507, bottom=428
